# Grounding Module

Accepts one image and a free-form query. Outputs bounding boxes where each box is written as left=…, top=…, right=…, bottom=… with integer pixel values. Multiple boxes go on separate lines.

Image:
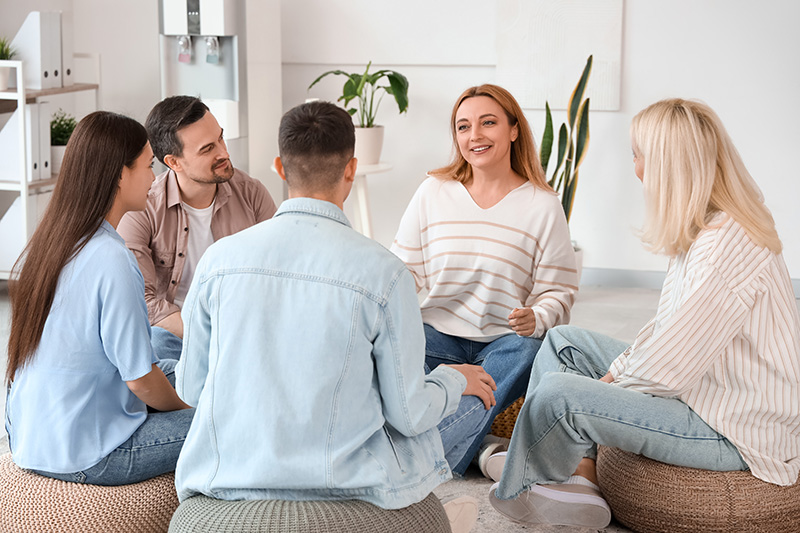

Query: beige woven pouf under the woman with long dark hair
left=0, top=453, right=178, bottom=533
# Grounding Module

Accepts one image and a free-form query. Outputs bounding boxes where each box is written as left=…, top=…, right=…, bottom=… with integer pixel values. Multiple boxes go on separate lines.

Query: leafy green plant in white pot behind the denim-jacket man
left=308, top=61, right=408, bottom=165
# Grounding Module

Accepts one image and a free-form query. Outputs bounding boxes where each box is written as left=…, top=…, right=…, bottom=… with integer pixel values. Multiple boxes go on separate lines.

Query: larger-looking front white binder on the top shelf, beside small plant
left=11, top=11, right=61, bottom=89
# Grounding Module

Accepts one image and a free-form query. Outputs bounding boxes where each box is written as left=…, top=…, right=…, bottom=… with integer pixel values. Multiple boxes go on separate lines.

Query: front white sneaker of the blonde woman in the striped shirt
left=489, top=483, right=611, bottom=529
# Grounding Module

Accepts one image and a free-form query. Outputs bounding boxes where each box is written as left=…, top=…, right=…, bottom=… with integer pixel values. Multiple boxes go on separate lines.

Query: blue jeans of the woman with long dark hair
left=32, top=359, right=194, bottom=485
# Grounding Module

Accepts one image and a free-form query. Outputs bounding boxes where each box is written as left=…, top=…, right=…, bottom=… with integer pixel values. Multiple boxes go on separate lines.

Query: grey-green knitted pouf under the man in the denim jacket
left=169, top=494, right=450, bottom=533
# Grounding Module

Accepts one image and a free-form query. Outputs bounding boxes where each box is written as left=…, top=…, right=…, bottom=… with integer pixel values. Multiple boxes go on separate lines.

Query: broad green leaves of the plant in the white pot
left=308, top=61, right=408, bottom=128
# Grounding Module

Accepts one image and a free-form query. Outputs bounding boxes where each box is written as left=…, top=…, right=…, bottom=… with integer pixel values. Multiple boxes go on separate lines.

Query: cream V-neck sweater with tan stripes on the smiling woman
left=392, top=177, right=578, bottom=342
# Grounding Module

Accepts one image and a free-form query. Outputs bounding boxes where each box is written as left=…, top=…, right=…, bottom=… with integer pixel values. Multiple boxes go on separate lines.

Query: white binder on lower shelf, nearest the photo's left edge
left=0, top=104, right=41, bottom=182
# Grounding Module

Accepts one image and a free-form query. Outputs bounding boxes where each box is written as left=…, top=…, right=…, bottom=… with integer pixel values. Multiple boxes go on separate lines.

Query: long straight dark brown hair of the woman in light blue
left=6, top=111, right=147, bottom=383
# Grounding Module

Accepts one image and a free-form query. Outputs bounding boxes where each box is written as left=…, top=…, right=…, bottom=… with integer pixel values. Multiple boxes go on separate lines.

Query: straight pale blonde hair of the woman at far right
left=631, top=98, right=782, bottom=256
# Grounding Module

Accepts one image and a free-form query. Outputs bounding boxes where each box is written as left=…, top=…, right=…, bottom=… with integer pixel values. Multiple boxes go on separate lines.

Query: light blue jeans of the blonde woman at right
left=496, top=326, right=748, bottom=499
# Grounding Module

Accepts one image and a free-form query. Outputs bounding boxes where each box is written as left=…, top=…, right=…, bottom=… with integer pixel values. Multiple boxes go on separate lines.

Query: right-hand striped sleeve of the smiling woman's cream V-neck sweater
left=525, top=195, right=578, bottom=337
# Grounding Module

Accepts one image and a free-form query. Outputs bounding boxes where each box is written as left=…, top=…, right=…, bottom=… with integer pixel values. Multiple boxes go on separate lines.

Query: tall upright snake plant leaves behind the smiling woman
left=539, top=56, right=592, bottom=222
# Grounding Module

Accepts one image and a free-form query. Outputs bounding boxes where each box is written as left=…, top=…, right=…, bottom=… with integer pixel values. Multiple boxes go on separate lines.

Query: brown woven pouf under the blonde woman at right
left=597, top=446, right=800, bottom=533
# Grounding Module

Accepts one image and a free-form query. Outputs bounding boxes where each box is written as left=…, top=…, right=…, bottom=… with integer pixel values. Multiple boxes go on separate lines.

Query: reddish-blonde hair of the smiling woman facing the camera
left=429, top=84, right=553, bottom=192
